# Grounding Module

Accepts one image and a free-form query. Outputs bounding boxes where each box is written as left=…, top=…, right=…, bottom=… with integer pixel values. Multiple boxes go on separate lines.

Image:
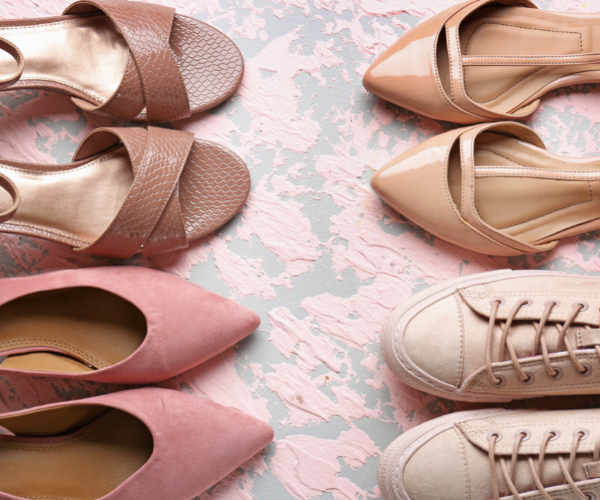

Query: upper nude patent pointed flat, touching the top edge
left=364, top=0, right=600, bottom=124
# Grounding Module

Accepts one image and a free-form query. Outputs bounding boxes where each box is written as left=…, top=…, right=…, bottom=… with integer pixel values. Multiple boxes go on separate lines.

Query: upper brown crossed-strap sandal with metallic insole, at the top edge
left=0, top=0, right=244, bottom=123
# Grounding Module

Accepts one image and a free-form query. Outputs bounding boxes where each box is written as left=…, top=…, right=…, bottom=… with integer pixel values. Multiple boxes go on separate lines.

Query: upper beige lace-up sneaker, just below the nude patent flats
left=381, top=271, right=600, bottom=402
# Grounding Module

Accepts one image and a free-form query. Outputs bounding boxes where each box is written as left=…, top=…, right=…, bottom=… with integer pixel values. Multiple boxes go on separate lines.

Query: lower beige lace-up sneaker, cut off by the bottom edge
left=378, top=409, right=600, bottom=500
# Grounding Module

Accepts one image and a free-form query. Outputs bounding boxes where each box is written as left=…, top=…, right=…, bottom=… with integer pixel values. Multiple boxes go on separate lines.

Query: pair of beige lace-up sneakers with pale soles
left=378, top=270, right=600, bottom=500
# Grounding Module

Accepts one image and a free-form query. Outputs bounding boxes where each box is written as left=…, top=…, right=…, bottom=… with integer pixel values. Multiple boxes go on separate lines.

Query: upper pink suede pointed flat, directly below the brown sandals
left=0, top=267, right=260, bottom=384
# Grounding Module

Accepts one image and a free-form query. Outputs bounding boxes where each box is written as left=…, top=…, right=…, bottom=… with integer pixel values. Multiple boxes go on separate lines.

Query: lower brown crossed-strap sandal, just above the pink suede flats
left=0, top=127, right=250, bottom=259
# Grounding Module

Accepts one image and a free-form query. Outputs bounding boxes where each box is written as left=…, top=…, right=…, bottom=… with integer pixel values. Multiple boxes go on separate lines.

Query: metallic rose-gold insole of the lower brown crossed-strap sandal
left=0, top=147, right=133, bottom=247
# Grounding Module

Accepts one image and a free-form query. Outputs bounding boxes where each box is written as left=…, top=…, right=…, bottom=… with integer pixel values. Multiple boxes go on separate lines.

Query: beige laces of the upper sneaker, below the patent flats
left=485, top=299, right=600, bottom=385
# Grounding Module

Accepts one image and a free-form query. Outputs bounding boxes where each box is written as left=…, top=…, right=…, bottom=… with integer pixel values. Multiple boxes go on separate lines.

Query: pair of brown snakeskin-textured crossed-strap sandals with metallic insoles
left=0, top=0, right=250, bottom=259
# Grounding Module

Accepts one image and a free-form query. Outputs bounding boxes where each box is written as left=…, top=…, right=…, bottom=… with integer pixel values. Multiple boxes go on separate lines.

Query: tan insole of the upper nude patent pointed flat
left=460, top=6, right=600, bottom=113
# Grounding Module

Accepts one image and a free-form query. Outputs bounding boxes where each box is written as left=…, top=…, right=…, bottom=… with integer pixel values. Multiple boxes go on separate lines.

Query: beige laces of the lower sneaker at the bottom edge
left=488, top=429, right=600, bottom=500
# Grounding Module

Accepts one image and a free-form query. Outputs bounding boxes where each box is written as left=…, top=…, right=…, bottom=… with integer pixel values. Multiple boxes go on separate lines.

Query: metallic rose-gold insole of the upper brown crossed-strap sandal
left=0, top=16, right=129, bottom=103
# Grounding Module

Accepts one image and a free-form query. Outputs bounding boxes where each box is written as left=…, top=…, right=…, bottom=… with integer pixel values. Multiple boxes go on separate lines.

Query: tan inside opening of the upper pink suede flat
left=0, top=287, right=147, bottom=373
